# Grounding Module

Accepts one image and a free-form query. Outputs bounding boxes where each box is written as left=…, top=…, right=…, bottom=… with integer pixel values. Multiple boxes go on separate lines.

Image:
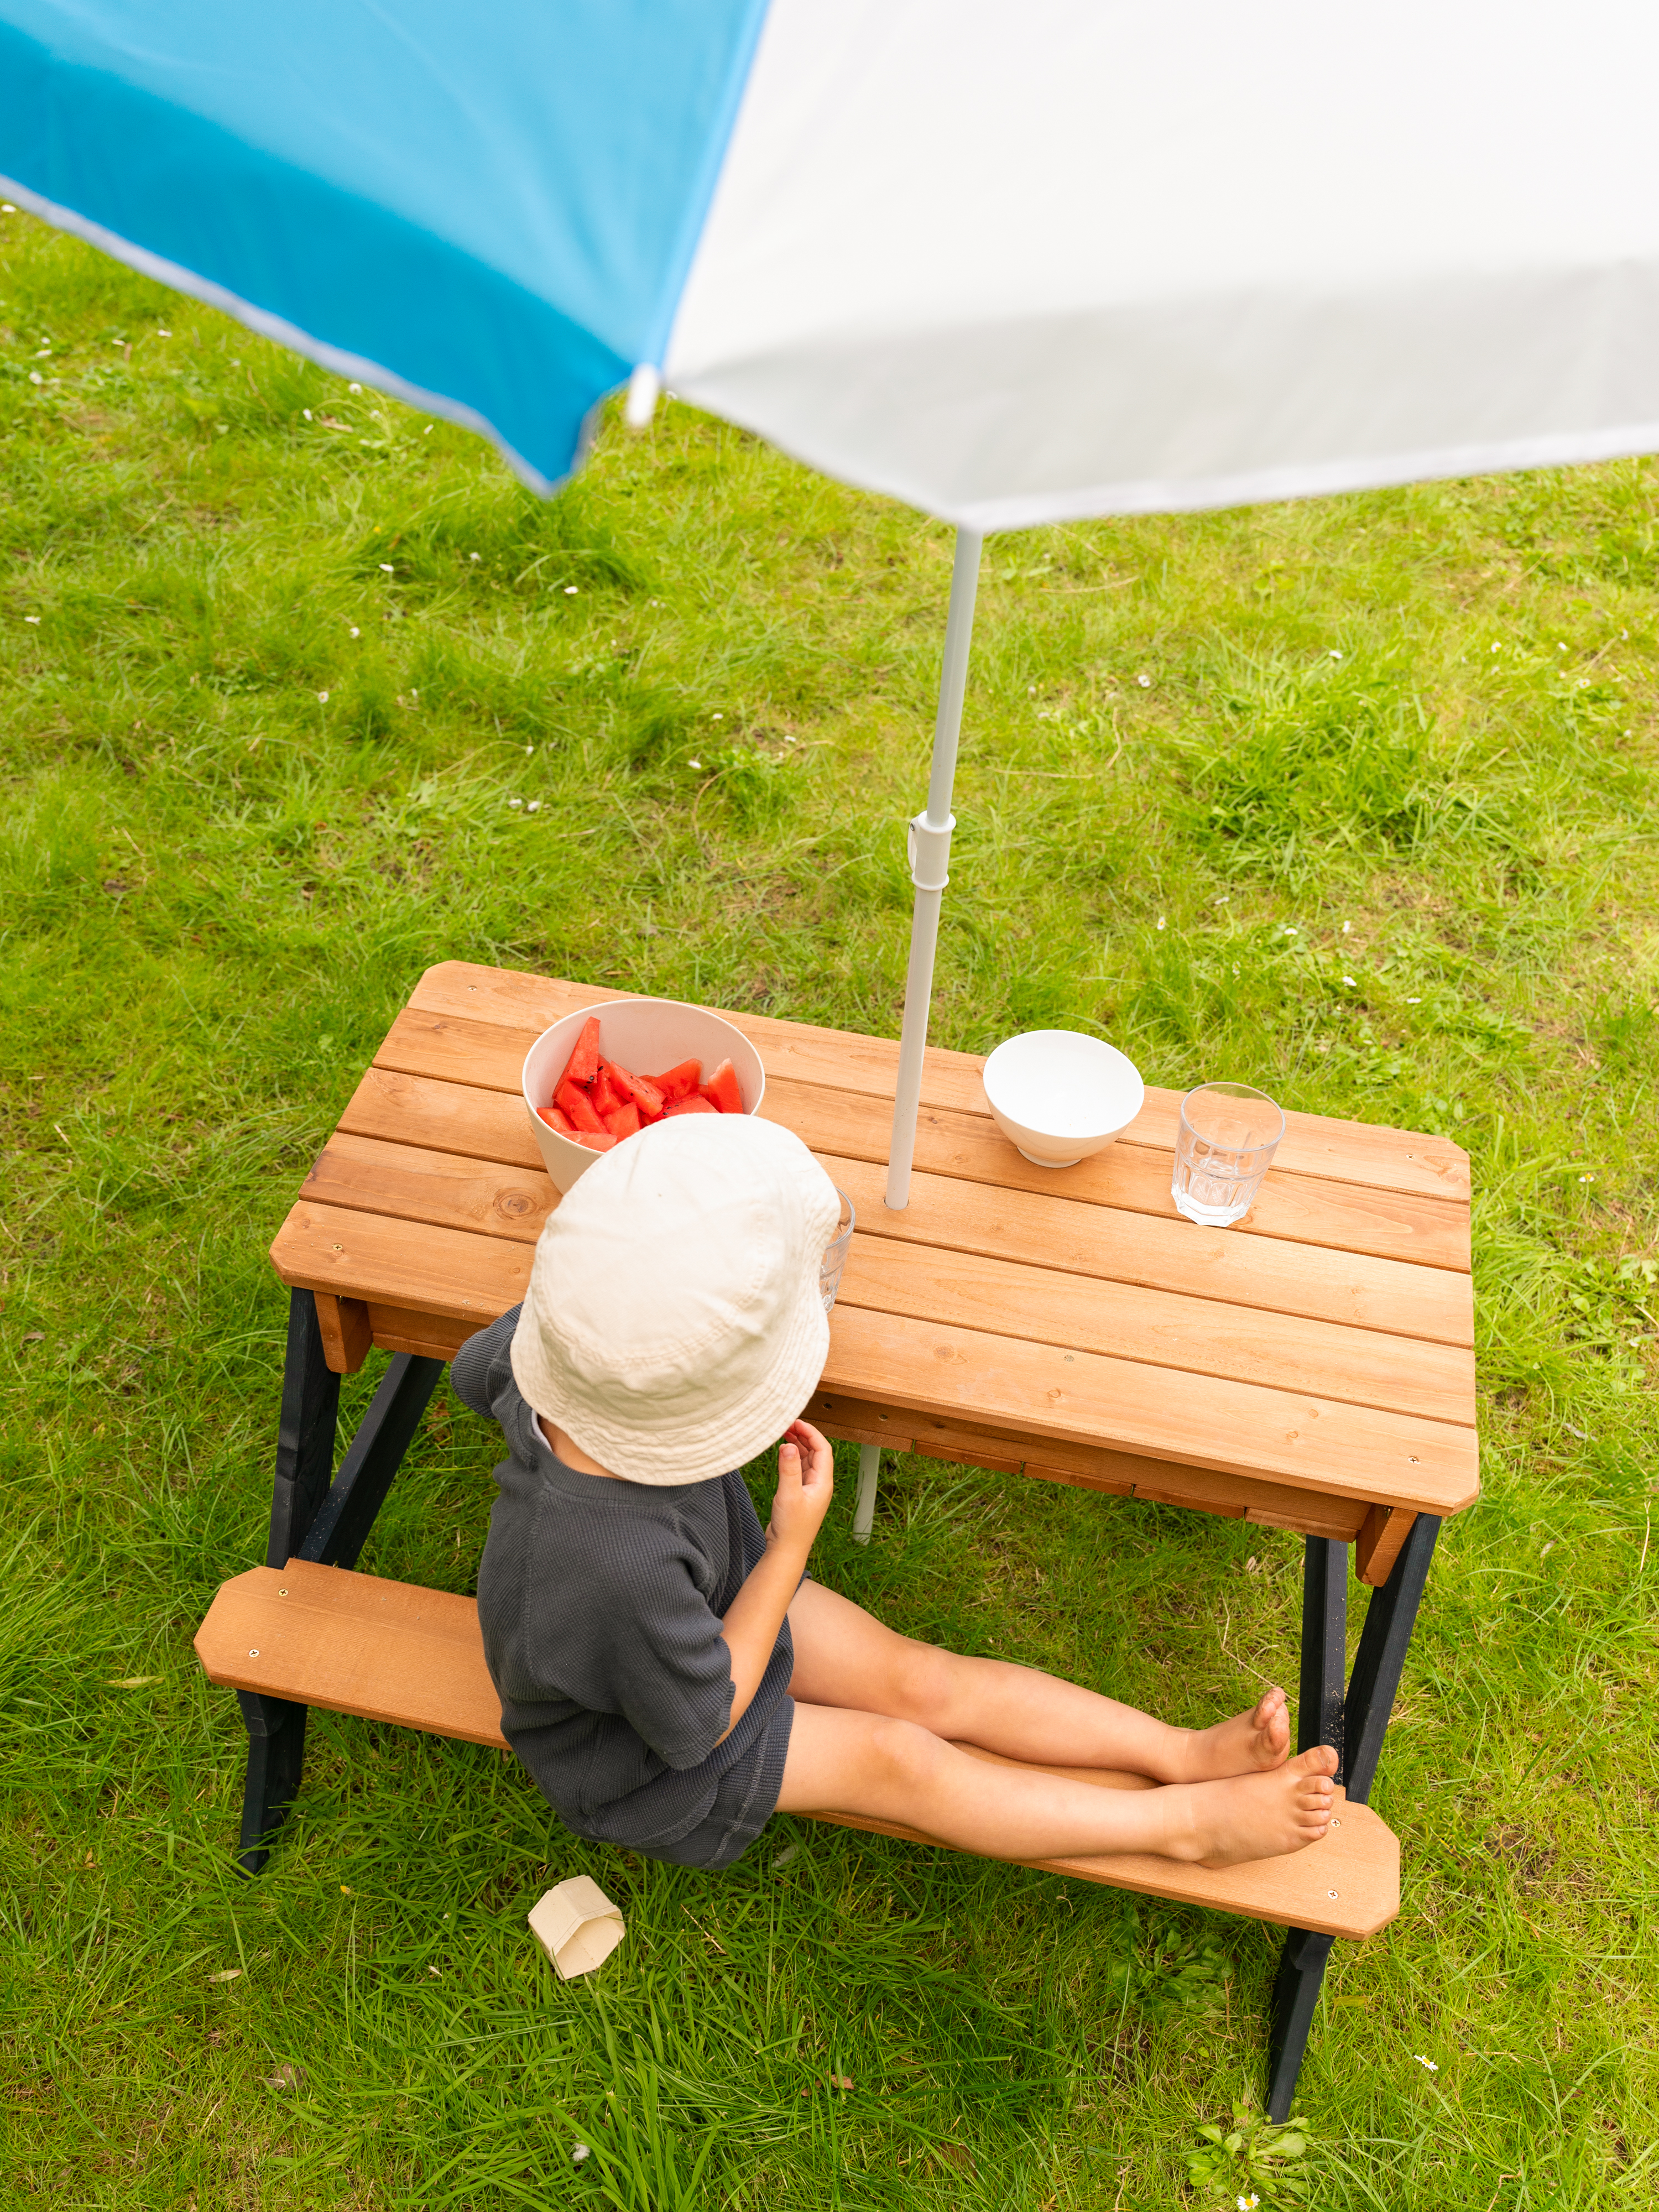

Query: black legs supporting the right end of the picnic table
left=1267, top=1513, right=1440, bottom=2119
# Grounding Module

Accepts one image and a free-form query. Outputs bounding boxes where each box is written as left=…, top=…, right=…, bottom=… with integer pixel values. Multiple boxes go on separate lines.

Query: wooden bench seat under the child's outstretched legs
left=195, top=1559, right=1400, bottom=1938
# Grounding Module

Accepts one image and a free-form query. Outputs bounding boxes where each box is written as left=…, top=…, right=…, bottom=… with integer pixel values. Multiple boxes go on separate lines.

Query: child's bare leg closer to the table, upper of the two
left=790, top=1582, right=1290, bottom=1783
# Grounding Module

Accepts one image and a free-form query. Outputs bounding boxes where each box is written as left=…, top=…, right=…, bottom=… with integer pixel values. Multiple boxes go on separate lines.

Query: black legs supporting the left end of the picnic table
left=237, top=1290, right=445, bottom=1876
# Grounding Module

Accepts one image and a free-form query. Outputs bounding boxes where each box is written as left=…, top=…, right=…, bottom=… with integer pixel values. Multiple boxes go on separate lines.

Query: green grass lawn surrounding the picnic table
left=0, top=215, right=1659, bottom=2212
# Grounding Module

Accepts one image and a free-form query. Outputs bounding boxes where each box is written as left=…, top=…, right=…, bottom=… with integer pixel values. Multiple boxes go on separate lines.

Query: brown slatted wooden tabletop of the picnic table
left=272, top=962, right=1478, bottom=1522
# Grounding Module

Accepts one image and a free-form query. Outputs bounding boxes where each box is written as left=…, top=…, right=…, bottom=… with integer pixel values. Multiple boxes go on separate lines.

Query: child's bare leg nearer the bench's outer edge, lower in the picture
left=779, top=1701, right=1336, bottom=1867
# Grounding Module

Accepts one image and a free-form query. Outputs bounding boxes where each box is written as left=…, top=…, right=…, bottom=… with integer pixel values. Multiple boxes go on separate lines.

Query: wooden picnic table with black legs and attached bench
left=201, top=960, right=1478, bottom=2110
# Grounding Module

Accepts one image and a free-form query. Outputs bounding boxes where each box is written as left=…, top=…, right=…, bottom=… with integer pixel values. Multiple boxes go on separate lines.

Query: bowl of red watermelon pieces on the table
left=524, top=998, right=765, bottom=1190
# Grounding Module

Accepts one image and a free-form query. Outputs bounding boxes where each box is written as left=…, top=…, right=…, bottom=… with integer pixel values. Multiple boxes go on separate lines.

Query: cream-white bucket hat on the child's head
left=513, top=1115, right=841, bottom=1484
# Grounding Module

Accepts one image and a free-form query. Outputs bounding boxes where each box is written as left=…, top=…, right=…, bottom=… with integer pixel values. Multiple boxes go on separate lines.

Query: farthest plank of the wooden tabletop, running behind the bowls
left=409, top=960, right=1469, bottom=1199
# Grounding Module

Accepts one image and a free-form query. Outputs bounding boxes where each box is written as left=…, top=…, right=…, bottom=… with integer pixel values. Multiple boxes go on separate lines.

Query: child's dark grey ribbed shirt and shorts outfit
left=449, top=1307, right=794, bottom=1851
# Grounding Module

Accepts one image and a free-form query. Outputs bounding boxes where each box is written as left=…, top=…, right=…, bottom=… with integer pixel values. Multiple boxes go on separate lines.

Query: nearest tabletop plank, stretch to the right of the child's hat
left=818, top=1305, right=1480, bottom=1513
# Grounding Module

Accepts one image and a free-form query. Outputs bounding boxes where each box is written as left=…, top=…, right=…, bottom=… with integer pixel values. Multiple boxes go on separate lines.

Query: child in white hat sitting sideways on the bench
left=451, top=1115, right=1336, bottom=1867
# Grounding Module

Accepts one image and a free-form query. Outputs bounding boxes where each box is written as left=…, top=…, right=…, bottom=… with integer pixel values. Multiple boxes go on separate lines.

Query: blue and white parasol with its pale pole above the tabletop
left=0, top=0, right=1659, bottom=1206
